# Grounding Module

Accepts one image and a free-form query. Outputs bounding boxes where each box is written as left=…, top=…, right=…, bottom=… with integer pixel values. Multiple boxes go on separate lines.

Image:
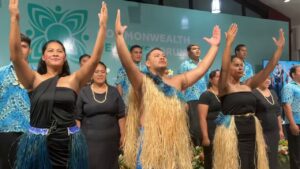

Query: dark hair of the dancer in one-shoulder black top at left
left=37, top=40, right=71, bottom=77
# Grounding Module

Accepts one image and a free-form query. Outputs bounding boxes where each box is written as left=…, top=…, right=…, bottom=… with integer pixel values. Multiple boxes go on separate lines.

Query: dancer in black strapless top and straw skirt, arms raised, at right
left=213, top=24, right=285, bottom=169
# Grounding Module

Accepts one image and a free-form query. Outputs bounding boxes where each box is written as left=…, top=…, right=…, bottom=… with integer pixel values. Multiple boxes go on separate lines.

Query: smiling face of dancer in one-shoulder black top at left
left=42, top=42, right=66, bottom=68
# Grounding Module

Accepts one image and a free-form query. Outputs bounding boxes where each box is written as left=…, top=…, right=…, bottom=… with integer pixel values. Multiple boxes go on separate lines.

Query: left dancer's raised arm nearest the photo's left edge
left=9, top=0, right=36, bottom=89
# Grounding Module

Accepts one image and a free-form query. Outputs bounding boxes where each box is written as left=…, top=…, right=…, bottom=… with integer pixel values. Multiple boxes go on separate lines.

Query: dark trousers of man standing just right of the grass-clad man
left=187, top=100, right=202, bottom=146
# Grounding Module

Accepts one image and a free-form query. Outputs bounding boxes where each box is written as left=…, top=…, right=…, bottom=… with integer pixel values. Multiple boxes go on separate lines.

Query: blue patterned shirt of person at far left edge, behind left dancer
left=0, top=64, right=30, bottom=132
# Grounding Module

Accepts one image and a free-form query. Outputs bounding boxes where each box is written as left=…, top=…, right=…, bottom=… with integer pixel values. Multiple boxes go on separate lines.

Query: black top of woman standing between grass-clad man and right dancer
left=199, top=90, right=221, bottom=120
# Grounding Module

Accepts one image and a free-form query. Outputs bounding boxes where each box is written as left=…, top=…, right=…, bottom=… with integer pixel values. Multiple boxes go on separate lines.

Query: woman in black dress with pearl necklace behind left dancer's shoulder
left=77, top=62, right=125, bottom=169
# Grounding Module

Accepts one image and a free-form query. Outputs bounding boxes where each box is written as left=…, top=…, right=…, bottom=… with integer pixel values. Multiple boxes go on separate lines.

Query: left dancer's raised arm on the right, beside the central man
left=74, top=2, right=108, bottom=87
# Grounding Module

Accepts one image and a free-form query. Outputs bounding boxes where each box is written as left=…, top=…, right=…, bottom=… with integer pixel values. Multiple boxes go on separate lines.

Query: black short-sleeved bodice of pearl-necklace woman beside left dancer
left=77, top=85, right=125, bottom=120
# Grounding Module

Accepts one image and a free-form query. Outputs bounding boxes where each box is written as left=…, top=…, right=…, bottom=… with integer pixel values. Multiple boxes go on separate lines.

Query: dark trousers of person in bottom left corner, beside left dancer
left=0, top=132, right=22, bottom=169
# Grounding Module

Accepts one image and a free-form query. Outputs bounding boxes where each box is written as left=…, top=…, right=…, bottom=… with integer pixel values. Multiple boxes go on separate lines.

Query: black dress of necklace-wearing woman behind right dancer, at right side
left=253, top=89, right=281, bottom=169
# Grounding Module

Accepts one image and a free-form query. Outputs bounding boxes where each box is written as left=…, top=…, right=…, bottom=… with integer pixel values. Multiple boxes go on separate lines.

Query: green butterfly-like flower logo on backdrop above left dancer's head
left=26, top=3, right=89, bottom=63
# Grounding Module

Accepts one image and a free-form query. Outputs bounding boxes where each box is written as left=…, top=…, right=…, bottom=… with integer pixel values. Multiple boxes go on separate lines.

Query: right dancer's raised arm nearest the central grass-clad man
left=219, top=24, right=238, bottom=96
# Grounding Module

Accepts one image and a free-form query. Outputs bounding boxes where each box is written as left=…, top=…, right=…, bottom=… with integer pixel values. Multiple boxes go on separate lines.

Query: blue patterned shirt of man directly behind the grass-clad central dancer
left=115, top=63, right=147, bottom=105
